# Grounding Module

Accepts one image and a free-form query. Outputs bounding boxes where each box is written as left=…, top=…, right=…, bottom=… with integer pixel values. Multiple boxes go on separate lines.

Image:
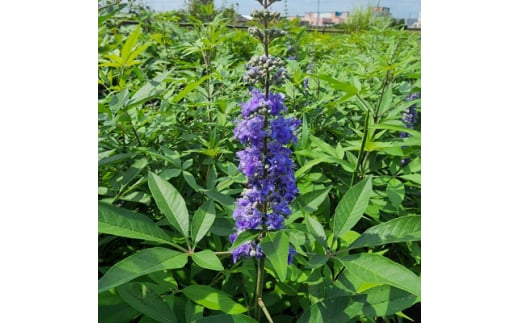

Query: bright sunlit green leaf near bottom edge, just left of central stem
left=181, top=285, right=247, bottom=314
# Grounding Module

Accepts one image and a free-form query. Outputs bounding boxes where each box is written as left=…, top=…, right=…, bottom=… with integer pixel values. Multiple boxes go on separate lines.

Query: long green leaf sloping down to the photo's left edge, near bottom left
left=98, top=247, right=188, bottom=293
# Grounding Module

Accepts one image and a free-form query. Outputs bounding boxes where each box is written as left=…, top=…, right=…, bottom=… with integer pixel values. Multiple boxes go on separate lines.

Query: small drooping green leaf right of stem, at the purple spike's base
left=260, top=231, right=289, bottom=282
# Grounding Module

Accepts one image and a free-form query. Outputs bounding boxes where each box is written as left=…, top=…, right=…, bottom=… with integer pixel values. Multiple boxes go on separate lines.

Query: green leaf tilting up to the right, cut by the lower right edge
left=348, top=215, right=421, bottom=249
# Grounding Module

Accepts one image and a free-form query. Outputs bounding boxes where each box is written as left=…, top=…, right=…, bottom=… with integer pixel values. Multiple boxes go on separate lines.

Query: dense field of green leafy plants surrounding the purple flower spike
left=98, top=0, right=421, bottom=323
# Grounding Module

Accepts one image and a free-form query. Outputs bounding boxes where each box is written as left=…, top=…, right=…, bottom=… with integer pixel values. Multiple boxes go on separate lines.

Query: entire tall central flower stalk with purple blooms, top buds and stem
left=230, top=0, right=301, bottom=321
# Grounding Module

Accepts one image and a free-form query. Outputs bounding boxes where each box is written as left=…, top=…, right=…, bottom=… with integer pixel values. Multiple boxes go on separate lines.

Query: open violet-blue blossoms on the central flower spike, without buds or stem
left=230, top=89, right=301, bottom=262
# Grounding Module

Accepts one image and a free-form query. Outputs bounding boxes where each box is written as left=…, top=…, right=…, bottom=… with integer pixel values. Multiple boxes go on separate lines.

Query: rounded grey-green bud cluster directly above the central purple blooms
left=243, top=55, right=289, bottom=86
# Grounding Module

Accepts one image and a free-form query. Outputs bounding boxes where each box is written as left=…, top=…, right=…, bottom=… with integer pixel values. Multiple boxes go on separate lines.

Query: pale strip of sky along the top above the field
left=147, top=0, right=421, bottom=18
